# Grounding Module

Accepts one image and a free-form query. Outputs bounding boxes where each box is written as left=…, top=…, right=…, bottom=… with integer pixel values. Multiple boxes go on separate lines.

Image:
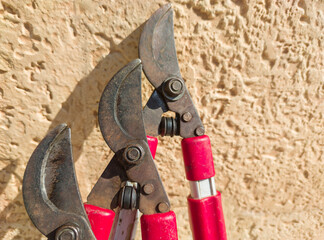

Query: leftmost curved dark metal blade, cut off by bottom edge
left=23, top=124, right=95, bottom=240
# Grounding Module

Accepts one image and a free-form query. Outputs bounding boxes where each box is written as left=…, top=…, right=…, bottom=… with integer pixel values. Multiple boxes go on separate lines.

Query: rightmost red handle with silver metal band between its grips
left=181, top=135, right=227, bottom=240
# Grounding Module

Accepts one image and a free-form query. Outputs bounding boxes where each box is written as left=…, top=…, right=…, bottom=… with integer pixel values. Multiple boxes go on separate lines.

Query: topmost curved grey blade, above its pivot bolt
left=139, top=4, right=181, bottom=88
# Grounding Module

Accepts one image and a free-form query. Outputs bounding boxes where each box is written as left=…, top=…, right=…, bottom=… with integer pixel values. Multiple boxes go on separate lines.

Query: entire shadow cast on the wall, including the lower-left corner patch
left=0, top=24, right=144, bottom=240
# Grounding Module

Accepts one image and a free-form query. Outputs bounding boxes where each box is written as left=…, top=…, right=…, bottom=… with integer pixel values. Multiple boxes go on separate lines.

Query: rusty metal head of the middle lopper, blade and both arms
left=88, top=59, right=170, bottom=214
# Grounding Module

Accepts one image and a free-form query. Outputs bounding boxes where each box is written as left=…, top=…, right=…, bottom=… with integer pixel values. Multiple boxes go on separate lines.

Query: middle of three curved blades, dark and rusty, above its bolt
left=98, top=59, right=146, bottom=152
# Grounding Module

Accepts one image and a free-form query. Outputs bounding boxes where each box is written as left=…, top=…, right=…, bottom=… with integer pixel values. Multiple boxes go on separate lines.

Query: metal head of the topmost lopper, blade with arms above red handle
left=139, top=4, right=204, bottom=138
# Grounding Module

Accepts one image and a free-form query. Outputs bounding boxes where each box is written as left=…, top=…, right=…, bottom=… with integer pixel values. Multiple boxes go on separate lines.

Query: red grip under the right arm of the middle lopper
left=141, top=211, right=178, bottom=240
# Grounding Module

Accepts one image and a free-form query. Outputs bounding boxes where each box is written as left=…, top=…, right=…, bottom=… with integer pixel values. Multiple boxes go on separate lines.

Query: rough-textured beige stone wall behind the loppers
left=0, top=0, right=324, bottom=240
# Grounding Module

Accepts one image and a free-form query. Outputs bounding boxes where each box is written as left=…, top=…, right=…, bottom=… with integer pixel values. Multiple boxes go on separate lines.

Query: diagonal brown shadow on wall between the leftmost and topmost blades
left=48, top=24, right=143, bottom=161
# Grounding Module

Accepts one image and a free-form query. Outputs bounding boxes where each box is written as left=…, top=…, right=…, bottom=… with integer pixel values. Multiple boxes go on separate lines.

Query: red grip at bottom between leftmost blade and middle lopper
left=84, top=203, right=115, bottom=240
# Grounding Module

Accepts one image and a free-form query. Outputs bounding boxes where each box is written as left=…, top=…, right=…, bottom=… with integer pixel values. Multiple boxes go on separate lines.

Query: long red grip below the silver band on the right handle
left=188, top=192, right=227, bottom=240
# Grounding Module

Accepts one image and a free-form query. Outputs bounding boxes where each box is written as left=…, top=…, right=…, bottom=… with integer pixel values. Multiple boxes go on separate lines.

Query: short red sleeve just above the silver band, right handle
left=181, top=135, right=215, bottom=181
